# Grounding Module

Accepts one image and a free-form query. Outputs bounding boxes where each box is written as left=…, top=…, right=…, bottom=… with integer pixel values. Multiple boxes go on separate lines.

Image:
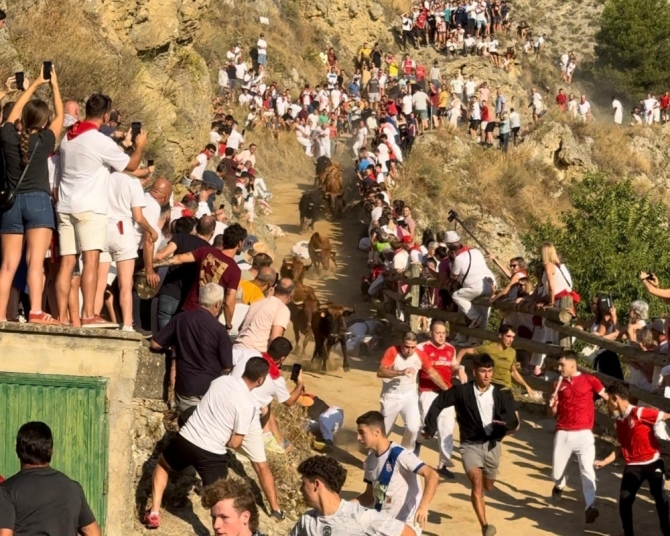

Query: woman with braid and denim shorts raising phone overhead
left=0, top=69, right=64, bottom=324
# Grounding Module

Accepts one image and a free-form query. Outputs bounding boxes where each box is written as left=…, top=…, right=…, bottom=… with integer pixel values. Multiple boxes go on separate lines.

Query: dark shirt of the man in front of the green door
left=0, top=467, right=95, bottom=536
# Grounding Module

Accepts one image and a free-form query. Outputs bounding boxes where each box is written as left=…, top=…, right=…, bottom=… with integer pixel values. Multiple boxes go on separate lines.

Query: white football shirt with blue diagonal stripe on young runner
left=363, top=442, right=424, bottom=524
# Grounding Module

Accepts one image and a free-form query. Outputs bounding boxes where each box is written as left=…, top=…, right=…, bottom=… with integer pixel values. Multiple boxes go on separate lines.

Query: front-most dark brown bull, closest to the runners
left=312, top=302, right=355, bottom=372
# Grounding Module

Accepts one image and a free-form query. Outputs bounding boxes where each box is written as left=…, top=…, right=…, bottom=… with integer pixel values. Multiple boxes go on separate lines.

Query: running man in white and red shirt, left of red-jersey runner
left=377, top=331, right=447, bottom=450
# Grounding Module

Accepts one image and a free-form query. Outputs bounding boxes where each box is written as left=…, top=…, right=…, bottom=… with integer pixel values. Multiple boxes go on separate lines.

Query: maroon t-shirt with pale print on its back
left=184, top=246, right=242, bottom=311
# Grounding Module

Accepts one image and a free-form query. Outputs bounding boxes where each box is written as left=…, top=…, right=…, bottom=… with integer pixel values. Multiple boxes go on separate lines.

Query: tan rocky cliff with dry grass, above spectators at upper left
left=0, top=0, right=212, bottom=178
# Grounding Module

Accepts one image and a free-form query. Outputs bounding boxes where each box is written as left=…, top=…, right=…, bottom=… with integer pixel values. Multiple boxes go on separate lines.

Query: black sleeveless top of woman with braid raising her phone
left=0, top=122, right=56, bottom=193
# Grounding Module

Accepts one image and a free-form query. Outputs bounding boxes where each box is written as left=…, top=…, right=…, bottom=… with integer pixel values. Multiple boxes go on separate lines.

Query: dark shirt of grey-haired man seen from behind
left=155, top=307, right=233, bottom=396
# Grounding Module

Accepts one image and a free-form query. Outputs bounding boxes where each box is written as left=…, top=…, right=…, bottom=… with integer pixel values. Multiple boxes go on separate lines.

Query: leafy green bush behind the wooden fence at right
left=523, top=174, right=670, bottom=316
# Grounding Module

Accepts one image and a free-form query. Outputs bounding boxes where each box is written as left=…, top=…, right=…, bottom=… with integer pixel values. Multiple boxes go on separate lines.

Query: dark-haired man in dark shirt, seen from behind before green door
left=0, top=422, right=102, bottom=536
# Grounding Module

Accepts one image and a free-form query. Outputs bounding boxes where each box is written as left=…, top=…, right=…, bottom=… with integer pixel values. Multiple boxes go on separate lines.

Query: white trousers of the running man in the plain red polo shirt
left=552, top=430, right=596, bottom=509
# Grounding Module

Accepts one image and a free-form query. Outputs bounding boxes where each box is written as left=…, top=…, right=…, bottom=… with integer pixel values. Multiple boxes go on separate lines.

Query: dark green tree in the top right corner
left=595, top=0, right=670, bottom=95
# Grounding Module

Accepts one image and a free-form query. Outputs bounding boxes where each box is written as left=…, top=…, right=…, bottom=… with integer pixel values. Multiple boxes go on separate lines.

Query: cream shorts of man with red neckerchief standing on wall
left=58, top=212, right=107, bottom=255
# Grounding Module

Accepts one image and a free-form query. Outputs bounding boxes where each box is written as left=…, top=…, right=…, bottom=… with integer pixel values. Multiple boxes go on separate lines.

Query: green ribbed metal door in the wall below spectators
left=0, top=372, right=109, bottom=527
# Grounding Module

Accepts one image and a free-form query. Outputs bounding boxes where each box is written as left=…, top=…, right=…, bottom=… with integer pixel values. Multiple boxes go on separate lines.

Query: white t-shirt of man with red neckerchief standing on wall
left=56, top=130, right=130, bottom=214
